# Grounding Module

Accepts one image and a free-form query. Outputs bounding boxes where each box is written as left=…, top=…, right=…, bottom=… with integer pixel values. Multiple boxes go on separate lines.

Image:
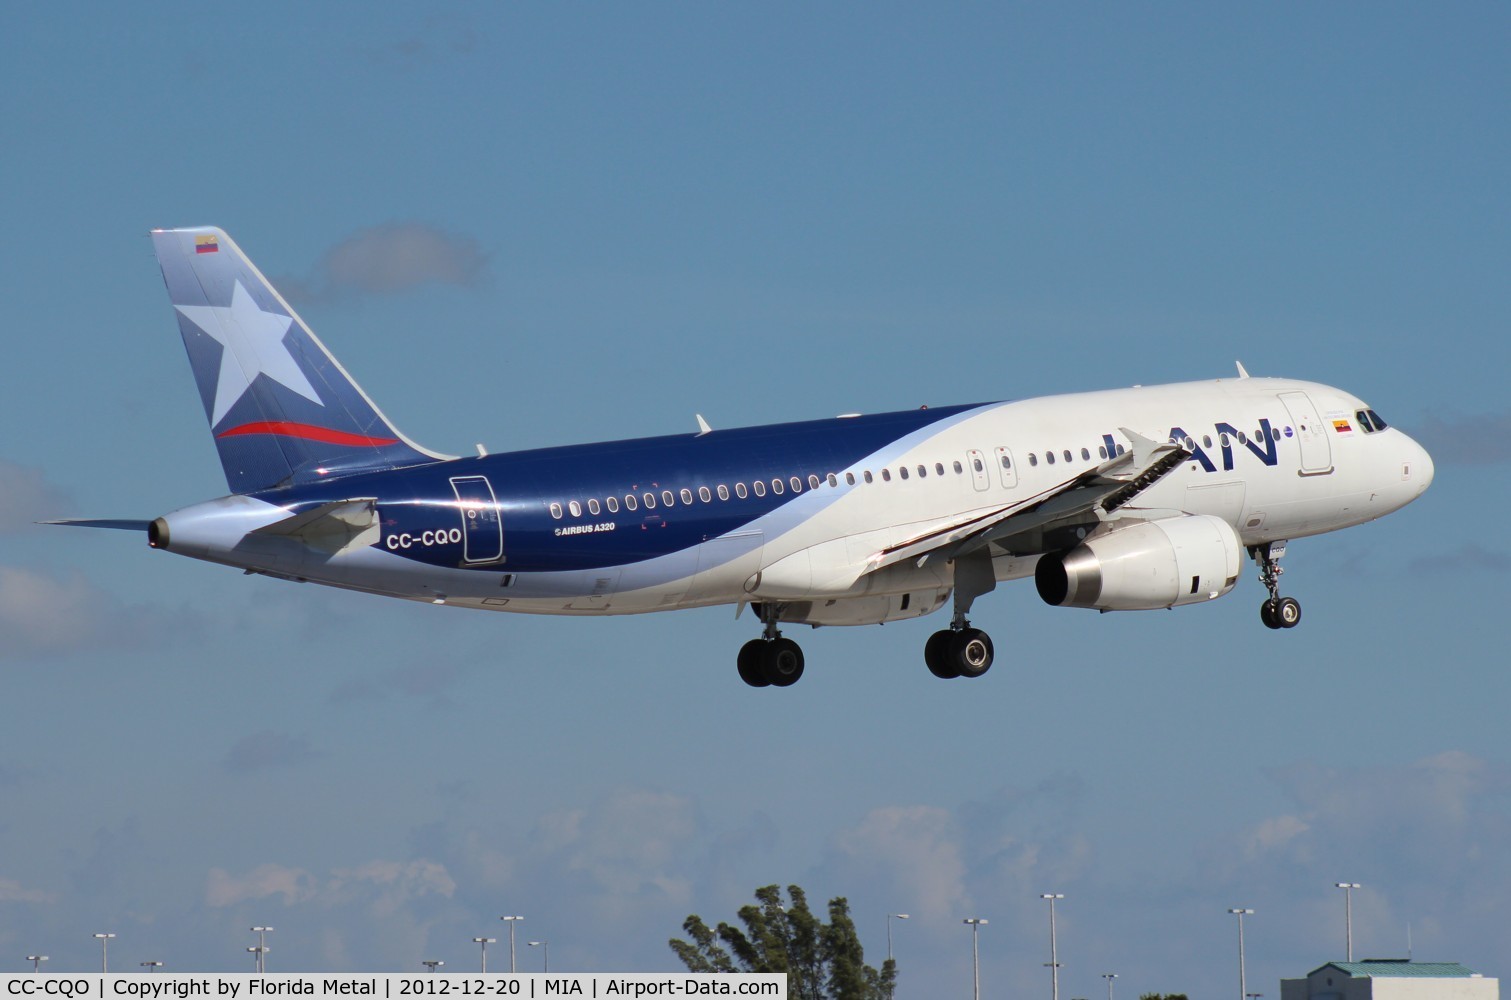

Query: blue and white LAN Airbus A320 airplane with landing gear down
left=53, top=228, right=1432, bottom=687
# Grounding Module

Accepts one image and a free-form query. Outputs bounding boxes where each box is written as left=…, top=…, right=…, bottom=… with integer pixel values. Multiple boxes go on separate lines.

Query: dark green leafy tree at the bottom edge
left=668, top=885, right=898, bottom=1000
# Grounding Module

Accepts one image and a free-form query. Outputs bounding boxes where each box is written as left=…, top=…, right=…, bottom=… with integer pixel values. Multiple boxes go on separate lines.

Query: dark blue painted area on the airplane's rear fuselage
left=249, top=405, right=979, bottom=573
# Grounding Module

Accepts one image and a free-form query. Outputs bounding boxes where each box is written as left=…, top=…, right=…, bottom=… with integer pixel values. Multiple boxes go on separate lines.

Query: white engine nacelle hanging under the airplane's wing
left=1034, top=514, right=1244, bottom=612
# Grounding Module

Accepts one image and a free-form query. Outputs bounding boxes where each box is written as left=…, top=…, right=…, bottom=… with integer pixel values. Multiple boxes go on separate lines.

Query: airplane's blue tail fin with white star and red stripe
left=153, top=227, right=449, bottom=492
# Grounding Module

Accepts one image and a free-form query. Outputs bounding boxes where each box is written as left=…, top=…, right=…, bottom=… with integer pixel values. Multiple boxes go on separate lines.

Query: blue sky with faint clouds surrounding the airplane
left=0, top=3, right=1511, bottom=997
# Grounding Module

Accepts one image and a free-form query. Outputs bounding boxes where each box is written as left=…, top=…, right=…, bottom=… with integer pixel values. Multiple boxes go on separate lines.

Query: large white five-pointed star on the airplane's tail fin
left=174, top=281, right=323, bottom=427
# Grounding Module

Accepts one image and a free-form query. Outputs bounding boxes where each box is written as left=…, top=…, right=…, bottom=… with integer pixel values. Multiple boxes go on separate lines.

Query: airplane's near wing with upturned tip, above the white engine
left=866, top=427, right=1191, bottom=573
